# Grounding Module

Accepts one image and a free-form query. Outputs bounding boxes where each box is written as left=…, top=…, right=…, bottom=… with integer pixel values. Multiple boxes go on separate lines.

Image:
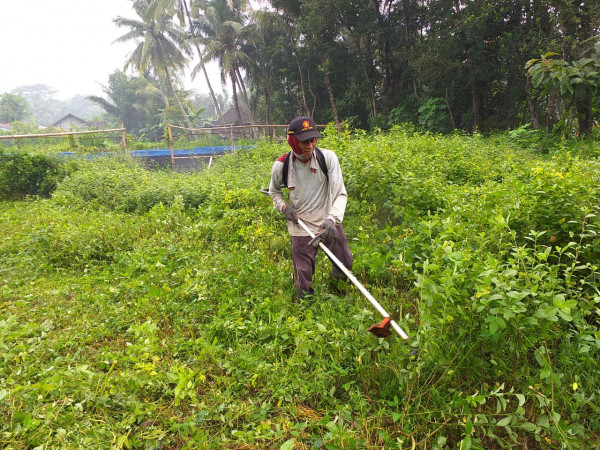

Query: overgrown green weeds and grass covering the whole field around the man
left=0, top=128, right=600, bottom=449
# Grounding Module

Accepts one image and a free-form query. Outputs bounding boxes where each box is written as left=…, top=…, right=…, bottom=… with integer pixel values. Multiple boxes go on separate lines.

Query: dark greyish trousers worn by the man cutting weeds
left=291, top=224, right=352, bottom=298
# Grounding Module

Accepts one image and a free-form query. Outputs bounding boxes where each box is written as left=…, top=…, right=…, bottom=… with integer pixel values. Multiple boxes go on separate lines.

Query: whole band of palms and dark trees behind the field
left=5, top=0, right=600, bottom=135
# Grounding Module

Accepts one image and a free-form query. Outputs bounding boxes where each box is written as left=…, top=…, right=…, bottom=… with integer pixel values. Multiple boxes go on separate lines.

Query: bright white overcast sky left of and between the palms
left=0, top=0, right=222, bottom=99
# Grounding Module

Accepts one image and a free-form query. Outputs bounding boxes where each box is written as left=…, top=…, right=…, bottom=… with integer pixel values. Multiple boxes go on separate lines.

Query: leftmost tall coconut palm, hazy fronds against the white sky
left=114, top=1, right=192, bottom=128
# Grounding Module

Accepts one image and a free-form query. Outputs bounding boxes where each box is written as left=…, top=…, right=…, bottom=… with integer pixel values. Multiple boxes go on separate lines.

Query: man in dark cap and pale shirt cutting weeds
left=269, top=117, right=352, bottom=299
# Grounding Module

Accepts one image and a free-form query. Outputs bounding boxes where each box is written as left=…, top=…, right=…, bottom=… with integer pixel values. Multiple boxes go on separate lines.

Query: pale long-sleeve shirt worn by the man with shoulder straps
left=269, top=149, right=348, bottom=236
